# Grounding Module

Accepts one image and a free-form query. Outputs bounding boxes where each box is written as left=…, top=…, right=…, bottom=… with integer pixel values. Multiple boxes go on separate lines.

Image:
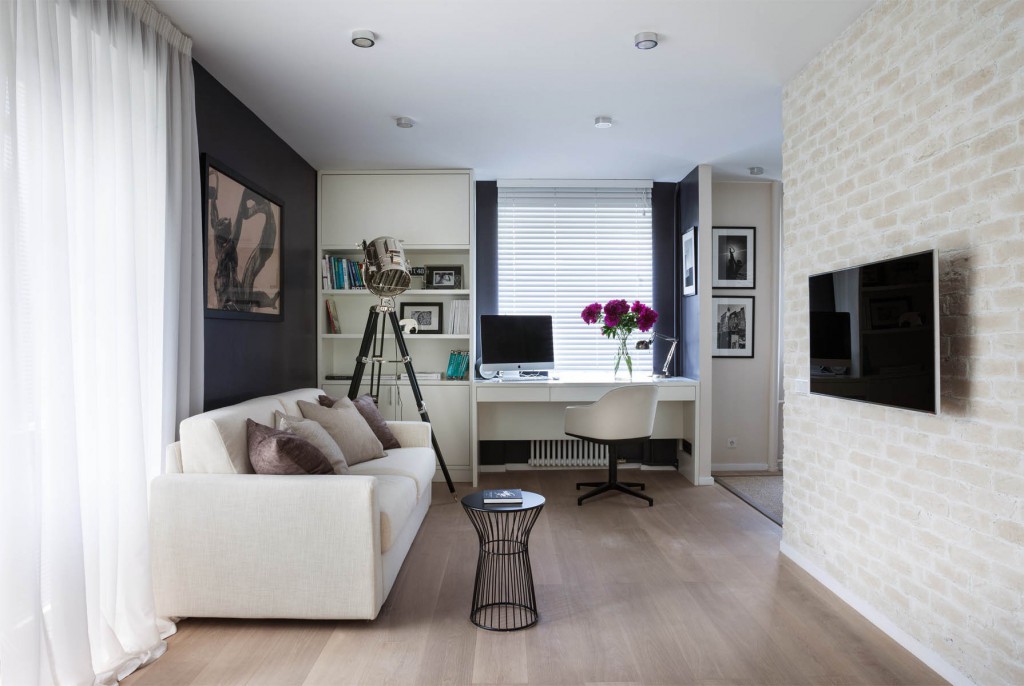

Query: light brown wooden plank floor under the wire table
left=124, top=471, right=944, bottom=686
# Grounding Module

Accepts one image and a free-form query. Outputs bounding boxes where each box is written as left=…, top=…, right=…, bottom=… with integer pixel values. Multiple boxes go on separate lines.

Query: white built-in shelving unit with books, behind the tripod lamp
left=316, top=170, right=476, bottom=481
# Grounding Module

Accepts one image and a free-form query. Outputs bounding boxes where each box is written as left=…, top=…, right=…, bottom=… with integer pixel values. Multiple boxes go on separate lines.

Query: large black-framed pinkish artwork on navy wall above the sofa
left=203, top=155, right=285, bottom=321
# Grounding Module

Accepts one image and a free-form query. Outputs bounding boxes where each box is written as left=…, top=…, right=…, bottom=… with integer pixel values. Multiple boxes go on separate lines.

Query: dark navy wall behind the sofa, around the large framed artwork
left=193, top=61, right=318, bottom=410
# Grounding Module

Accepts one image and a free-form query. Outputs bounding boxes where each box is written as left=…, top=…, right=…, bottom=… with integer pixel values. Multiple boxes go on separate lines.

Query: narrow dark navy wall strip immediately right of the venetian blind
left=651, top=182, right=679, bottom=376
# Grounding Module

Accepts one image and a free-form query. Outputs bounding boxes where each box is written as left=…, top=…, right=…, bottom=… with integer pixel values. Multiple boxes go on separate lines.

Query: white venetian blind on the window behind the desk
left=498, top=181, right=653, bottom=374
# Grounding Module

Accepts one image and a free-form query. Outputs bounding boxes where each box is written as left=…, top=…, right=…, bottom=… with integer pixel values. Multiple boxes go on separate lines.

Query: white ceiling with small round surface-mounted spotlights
left=154, top=0, right=873, bottom=181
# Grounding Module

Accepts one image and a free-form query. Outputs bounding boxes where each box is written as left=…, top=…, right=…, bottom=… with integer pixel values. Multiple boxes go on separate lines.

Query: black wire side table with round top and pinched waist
left=462, top=490, right=545, bottom=631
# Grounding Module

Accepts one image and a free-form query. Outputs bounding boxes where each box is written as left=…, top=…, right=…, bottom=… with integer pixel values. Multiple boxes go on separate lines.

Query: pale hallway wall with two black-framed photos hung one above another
left=705, top=181, right=776, bottom=472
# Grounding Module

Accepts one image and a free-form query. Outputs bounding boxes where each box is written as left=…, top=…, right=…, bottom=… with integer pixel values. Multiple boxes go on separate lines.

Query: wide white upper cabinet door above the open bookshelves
left=321, top=172, right=470, bottom=247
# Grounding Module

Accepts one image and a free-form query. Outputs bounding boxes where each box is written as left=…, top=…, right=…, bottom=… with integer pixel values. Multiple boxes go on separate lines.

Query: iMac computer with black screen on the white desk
left=480, top=314, right=555, bottom=378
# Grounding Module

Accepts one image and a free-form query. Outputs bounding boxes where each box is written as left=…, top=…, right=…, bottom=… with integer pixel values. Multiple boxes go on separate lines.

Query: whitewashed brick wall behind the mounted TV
left=783, top=0, right=1024, bottom=684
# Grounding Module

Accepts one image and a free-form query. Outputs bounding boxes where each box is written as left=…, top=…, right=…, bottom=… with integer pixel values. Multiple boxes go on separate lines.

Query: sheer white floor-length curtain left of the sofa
left=0, top=0, right=203, bottom=686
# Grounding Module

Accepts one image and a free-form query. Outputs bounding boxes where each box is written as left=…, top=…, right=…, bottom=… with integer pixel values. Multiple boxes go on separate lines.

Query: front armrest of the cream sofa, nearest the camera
left=150, top=474, right=384, bottom=619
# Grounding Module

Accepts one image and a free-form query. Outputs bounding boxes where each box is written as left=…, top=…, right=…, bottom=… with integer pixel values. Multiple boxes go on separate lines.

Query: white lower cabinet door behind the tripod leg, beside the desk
left=398, top=385, right=472, bottom=481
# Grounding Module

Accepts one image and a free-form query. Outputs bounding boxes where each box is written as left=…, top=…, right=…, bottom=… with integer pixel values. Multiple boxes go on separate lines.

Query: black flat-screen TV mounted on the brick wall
left=808, top=250, right=939, bottom=414
